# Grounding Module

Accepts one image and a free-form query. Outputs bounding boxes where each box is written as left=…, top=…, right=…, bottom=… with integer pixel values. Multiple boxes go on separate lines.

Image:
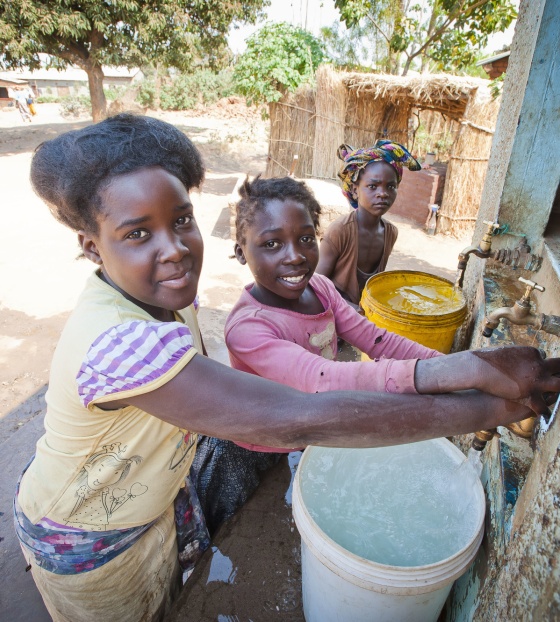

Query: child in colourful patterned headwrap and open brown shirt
left=317, top=140, right=421, bottom=309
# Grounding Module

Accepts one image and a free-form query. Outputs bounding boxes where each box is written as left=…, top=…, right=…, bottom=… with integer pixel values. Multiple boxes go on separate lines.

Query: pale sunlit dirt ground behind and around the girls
left=0, top=100, right=470, bottom=622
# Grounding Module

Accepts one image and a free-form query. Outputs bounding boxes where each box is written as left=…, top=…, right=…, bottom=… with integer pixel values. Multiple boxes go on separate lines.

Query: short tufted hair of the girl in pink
left=235, top=175, right=321, bottom=244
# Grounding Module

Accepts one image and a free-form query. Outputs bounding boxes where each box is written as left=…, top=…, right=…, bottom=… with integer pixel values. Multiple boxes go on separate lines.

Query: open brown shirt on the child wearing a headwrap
left=322, top=210, right=398, bottom=304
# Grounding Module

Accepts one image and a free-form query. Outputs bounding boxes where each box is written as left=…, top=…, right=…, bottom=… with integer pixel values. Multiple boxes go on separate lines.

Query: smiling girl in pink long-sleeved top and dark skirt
left=192, top=177, right=439, bottom=532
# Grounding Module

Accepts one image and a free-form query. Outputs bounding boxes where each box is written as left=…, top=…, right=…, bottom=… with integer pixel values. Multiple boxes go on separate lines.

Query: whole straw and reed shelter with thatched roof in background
left=266, top=65, right=499, bottom=235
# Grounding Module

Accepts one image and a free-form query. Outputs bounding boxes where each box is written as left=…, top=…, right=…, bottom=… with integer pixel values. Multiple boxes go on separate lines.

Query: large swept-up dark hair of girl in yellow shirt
left=31, top=113, right=204, bottom=233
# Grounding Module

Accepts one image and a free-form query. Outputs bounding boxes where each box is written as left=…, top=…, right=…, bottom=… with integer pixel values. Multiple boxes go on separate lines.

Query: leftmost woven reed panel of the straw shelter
left=266, top=87, right=315, bottom=177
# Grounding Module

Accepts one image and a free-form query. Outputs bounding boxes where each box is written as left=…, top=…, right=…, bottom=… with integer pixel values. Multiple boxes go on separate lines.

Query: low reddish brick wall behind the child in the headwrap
left=389, top=163, right=447, bottom=226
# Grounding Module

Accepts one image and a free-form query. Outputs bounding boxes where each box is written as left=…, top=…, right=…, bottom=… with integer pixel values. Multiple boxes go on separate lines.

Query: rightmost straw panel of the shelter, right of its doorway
left=438, top=89, right=500, bottom=237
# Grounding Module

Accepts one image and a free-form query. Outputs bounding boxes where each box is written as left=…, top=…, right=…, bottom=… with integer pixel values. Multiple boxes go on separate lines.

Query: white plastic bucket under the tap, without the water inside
left=292, top=439, right=486, bottom=622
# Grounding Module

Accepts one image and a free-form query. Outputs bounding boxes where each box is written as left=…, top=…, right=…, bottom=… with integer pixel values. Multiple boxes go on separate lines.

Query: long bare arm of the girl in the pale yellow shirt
left=105, top=354, right=540, bottom=447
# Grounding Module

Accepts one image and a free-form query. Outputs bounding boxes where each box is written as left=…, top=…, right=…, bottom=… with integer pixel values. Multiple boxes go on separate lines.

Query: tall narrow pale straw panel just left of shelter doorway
left=312, top=65, right=347, bottom=179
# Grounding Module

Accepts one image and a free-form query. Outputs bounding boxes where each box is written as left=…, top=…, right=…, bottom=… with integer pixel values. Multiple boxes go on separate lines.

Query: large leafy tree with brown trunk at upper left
left=0, top=0, right=269, bottom=120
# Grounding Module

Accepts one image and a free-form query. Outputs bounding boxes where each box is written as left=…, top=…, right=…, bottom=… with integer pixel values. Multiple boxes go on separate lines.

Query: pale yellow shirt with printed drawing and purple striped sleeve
left=18, top=273, right=202, bottom=531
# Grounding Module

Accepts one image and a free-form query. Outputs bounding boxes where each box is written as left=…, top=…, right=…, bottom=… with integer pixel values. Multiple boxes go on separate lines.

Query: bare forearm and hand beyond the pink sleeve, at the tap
left=414, top=346, right=560, bottom=415
